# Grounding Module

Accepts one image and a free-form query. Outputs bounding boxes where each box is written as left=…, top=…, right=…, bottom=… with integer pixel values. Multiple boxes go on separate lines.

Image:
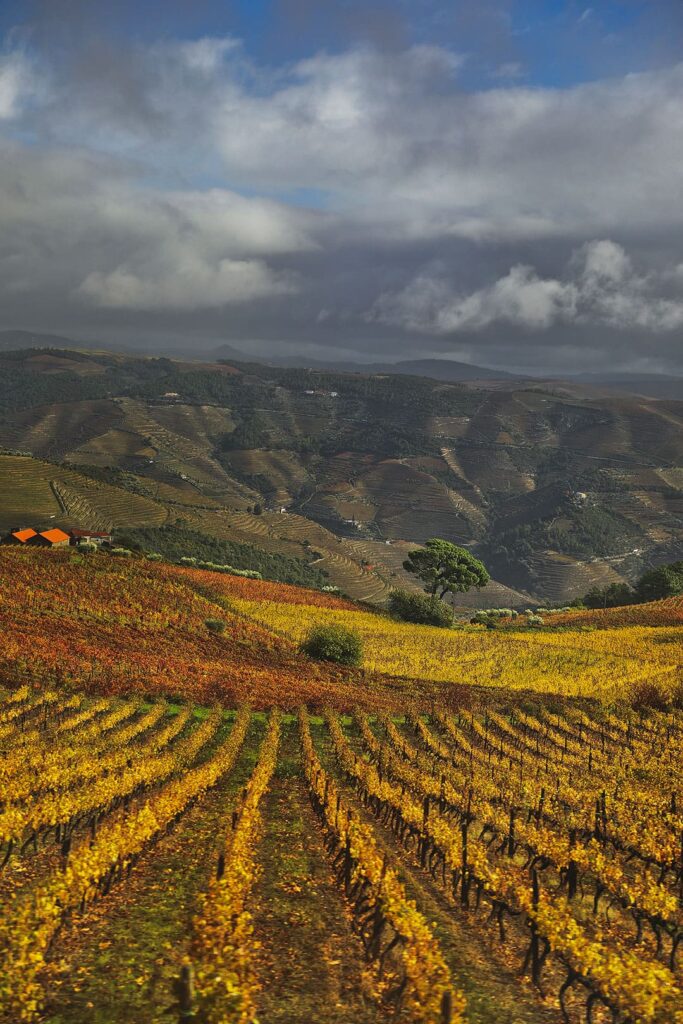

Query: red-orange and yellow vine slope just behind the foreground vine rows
left=0, top=547, right=683, bottom=709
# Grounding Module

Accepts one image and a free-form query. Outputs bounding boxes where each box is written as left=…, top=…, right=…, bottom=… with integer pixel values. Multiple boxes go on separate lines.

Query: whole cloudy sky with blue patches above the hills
left=0, top=0, right=683, bottom=375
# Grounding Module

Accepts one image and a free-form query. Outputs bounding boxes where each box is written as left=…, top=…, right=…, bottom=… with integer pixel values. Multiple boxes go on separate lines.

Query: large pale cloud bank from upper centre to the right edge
left=201, top=46, right=683, bottom=239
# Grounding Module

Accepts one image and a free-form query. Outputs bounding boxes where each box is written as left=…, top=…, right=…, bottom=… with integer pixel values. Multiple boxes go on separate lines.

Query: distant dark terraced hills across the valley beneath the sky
left=0, top=349, right=683, bottom=606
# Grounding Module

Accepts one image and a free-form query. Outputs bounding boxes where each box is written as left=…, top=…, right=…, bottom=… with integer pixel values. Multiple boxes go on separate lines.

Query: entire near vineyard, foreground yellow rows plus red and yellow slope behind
left=0, top=548, right=683, bottom=1024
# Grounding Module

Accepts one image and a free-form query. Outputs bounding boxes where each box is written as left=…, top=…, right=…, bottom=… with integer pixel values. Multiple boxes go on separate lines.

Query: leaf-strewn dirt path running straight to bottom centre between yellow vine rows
left=253, top=722, right=384, bottom=1024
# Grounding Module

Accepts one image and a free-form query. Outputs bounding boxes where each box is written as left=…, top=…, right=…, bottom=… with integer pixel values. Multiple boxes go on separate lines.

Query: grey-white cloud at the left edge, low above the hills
left=0, top=143, right=316, bottom=310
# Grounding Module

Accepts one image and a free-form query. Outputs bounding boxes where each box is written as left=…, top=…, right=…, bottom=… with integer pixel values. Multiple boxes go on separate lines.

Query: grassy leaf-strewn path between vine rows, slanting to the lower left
left=44, top=719, right=263, bottom=1024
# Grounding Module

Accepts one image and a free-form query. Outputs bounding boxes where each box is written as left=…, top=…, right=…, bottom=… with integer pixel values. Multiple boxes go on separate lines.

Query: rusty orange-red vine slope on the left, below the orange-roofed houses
left=0, top=548, right=395, bottom=709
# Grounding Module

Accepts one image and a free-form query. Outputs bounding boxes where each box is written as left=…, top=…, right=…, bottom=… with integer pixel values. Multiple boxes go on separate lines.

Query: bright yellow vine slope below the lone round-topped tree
left=227, top=599, right=683, bottom=700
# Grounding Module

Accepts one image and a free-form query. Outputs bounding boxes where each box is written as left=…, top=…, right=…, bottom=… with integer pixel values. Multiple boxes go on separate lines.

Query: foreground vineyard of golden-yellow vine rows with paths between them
left=0, top=687, right=683, bottom=1024
